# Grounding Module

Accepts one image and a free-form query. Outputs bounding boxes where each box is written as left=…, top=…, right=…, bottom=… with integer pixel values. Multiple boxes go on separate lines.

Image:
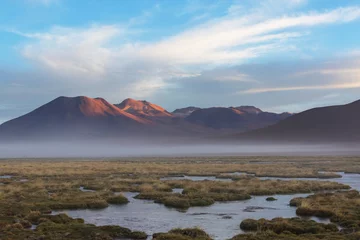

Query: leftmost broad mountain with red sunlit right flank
left=0, top=96, right=151, bottom=139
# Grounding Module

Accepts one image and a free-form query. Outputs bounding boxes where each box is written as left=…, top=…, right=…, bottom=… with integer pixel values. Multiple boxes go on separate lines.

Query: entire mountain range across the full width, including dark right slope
left=0, top=96, right=360, bottom=142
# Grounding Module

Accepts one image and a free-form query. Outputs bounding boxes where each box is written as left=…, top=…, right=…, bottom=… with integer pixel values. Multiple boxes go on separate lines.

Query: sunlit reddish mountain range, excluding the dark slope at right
left=0, top=96, right=291, bottom=140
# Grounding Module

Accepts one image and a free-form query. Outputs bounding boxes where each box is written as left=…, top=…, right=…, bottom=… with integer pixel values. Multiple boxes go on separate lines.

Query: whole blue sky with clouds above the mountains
left=0, top=0, right=360, bottom=123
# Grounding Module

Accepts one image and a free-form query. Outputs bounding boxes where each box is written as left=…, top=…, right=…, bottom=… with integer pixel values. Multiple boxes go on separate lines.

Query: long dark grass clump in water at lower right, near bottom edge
left=240, top=218, right=339, bottom=235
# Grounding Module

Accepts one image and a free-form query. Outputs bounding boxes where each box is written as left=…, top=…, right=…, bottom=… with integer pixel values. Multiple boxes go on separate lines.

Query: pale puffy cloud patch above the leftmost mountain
left=19, top=26, right=122, bottom=77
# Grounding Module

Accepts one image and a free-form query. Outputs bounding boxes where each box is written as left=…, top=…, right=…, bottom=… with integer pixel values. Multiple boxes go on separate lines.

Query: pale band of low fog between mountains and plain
left=0, top=141, right=360, bottom=158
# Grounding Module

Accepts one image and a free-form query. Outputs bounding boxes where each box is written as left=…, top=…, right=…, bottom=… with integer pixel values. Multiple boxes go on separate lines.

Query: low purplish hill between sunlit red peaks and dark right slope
left=185, top=106, right=291, bottom=131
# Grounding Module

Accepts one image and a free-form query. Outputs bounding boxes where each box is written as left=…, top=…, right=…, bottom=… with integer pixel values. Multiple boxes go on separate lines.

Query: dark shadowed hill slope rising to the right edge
left=237, top=101, right=360, bottom=143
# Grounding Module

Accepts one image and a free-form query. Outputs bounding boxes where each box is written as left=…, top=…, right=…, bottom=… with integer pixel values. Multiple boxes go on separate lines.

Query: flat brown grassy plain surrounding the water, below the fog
left=0, top=156, right=360, bottom=240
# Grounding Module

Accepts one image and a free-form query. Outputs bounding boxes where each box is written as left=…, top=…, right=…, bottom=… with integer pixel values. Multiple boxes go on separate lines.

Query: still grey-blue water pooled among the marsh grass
left=56, top=173, right=360, bottom=240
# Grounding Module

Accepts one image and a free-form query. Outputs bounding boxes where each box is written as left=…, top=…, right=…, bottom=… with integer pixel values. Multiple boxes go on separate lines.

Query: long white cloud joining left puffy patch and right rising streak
left=13, top=7, right=360, bottom=73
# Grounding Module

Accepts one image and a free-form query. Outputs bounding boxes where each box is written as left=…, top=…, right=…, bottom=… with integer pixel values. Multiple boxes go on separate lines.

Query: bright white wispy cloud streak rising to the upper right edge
left=118, top=7, right=360, bottom=64
